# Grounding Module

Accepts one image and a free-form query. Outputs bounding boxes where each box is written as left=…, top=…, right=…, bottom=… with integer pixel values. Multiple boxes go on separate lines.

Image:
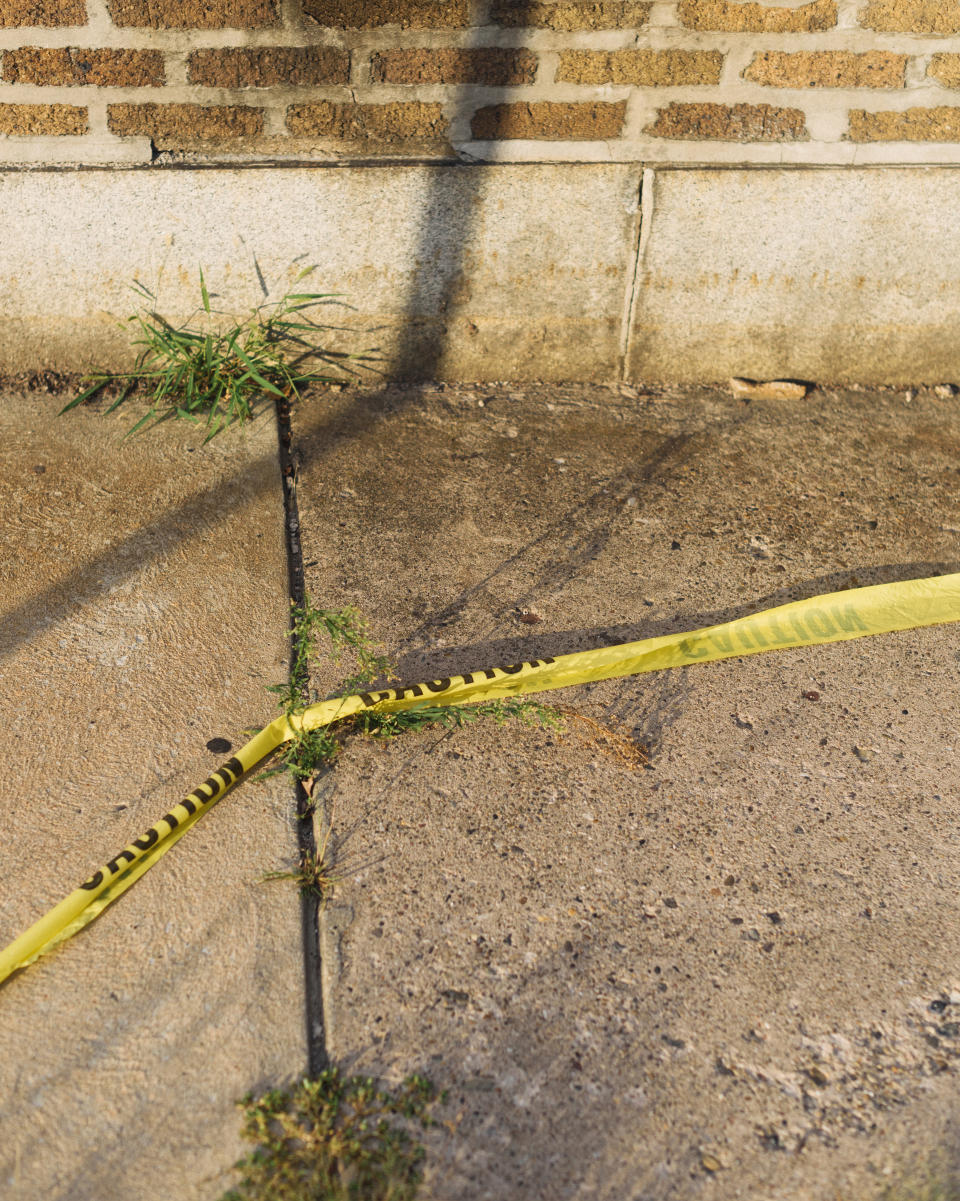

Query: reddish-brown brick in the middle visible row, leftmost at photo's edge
left=0, top=46, right=163, bottom=88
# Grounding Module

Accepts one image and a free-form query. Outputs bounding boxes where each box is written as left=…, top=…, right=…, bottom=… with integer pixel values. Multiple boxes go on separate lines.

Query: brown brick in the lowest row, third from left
left=287, top=101, right=448, bottom=145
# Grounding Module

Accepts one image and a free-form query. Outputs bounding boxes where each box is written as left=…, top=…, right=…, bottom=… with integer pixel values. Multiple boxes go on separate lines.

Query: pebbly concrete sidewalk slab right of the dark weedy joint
left=297, top=388, right=960, bottom=1201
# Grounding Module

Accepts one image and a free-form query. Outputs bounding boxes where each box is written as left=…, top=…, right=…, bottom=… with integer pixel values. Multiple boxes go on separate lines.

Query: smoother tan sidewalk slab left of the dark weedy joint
left=0, top=393, right=306, bottom=1201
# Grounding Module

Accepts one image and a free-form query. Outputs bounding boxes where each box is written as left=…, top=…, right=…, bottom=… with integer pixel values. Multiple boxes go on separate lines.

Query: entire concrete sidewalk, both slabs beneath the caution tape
left=0, top=386, right=960, bottom=1201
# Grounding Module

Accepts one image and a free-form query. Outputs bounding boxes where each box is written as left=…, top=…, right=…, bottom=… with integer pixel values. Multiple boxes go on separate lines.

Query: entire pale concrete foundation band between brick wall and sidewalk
left=0, top=163, right=960, bottom=383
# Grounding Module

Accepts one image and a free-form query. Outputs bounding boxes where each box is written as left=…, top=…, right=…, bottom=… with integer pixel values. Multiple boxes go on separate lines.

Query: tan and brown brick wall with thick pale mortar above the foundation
left=0, top=0, right=960, bottom=163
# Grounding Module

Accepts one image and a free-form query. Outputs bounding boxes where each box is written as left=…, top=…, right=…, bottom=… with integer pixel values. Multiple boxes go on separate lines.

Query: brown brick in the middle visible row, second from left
left=187, top=46, right=350, bottom=88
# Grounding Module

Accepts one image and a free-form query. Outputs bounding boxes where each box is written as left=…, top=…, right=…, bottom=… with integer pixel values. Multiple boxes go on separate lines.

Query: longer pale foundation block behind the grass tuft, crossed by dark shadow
left=0, top=165, right=639, bottom=378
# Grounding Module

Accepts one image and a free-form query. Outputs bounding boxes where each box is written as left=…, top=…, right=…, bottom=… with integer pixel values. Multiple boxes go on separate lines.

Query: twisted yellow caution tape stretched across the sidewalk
left=0, top=573, right=960, bottom=981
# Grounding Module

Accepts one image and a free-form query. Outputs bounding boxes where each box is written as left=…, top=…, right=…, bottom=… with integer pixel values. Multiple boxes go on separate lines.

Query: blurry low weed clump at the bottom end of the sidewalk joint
left=222, top=1068, right=443, bottom=1201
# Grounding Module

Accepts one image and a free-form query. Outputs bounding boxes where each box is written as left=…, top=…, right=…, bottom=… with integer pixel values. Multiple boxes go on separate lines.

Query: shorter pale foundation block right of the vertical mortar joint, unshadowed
left=630, top=168, right=960, bottom=383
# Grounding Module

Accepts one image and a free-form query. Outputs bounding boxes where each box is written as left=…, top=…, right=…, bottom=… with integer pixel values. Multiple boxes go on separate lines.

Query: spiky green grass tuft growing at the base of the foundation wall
left=54, top=267, right=374, bottom=442
